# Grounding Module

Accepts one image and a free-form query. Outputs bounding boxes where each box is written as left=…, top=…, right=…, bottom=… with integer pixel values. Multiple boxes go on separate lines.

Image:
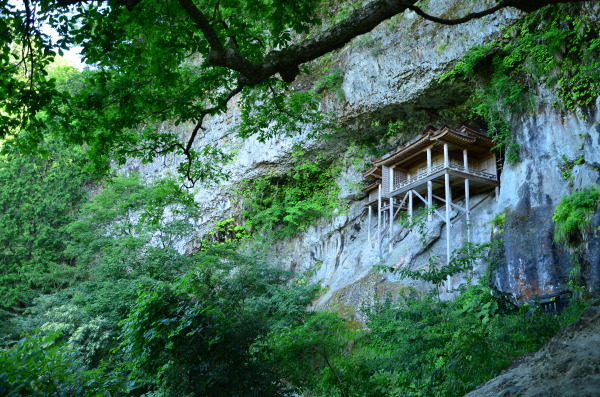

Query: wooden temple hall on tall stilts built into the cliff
left=363, top=125, right=499, bottom=270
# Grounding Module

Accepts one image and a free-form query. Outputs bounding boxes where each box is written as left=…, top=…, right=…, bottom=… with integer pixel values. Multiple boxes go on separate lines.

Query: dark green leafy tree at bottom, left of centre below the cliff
left=120, top=250, right=315, bottom=396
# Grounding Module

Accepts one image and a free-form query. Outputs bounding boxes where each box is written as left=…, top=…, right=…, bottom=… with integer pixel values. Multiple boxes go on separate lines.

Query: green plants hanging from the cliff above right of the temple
left=442, top=4, right=600, bottom=162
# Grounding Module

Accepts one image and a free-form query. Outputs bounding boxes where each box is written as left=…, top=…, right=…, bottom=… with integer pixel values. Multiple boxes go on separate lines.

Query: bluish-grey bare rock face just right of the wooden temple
left=496, top=98, right=600, bottom=302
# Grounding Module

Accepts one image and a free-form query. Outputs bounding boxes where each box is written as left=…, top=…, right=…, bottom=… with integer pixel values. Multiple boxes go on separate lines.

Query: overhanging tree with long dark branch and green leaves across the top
left=0, top=0, right=592, bottom=182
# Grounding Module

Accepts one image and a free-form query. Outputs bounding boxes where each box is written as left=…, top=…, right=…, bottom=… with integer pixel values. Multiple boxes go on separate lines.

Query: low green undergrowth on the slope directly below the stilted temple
left=266, top=286, right=583, bottom=397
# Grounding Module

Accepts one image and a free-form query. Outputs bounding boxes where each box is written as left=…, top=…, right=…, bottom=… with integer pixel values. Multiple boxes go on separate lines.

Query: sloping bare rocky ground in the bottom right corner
left=467, top=306, right=600, bottom=397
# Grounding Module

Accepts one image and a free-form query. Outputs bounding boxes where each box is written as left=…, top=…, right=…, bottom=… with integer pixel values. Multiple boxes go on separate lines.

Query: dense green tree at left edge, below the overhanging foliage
left=0, top=141, right=90, bottom=309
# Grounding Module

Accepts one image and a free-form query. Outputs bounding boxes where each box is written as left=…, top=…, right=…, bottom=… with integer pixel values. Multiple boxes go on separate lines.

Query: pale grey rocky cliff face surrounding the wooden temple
left=128, top=0, right=600, bottom=307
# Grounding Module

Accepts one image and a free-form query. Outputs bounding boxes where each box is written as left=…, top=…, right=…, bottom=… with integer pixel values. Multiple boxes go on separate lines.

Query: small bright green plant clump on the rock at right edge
left=552, top=185, right=600, bottom=247
